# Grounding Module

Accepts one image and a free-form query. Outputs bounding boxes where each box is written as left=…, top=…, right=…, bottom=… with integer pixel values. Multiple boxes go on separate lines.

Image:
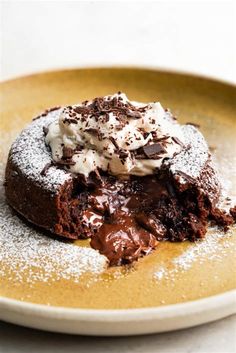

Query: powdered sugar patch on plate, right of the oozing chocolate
left=153, top=227, right=235, bottom=281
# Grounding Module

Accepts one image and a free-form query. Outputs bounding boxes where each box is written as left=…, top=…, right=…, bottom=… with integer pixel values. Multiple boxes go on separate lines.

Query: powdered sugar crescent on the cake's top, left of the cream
left=11, top=109, right=71, bottom=192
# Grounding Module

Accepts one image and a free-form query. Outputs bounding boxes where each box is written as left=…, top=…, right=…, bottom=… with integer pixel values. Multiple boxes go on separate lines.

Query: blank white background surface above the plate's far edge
left=0, top=0, right=236, bottom=82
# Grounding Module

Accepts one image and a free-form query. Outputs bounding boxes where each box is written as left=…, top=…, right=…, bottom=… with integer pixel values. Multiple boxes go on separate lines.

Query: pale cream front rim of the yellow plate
left=0, top=289, right=236, bottom=322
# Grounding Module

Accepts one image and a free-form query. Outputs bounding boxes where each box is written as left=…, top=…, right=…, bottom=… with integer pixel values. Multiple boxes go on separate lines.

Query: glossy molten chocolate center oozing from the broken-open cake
left=70, top=175, right=205, bottom=265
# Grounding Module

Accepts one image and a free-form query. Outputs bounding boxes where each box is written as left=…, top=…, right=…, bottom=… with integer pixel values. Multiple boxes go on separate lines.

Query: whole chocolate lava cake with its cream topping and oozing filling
left=5, top=92, right=236, bottom=265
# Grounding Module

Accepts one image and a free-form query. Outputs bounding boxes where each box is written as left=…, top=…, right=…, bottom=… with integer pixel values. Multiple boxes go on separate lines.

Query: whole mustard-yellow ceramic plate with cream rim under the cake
left=0, top=68, right=236, bottom=335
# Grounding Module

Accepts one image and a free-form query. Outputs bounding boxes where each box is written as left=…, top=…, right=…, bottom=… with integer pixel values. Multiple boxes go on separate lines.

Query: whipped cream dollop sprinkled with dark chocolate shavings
left=46, top=92, right=184, bottom=177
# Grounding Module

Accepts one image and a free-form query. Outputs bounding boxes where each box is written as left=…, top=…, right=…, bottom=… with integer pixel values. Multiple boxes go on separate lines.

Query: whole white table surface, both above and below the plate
left=0, top=0, right=236, bottom=353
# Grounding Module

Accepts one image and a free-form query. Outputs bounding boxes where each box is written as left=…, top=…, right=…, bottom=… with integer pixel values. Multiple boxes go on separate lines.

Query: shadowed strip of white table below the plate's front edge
left=0, top=316, right=236, bottom=353
